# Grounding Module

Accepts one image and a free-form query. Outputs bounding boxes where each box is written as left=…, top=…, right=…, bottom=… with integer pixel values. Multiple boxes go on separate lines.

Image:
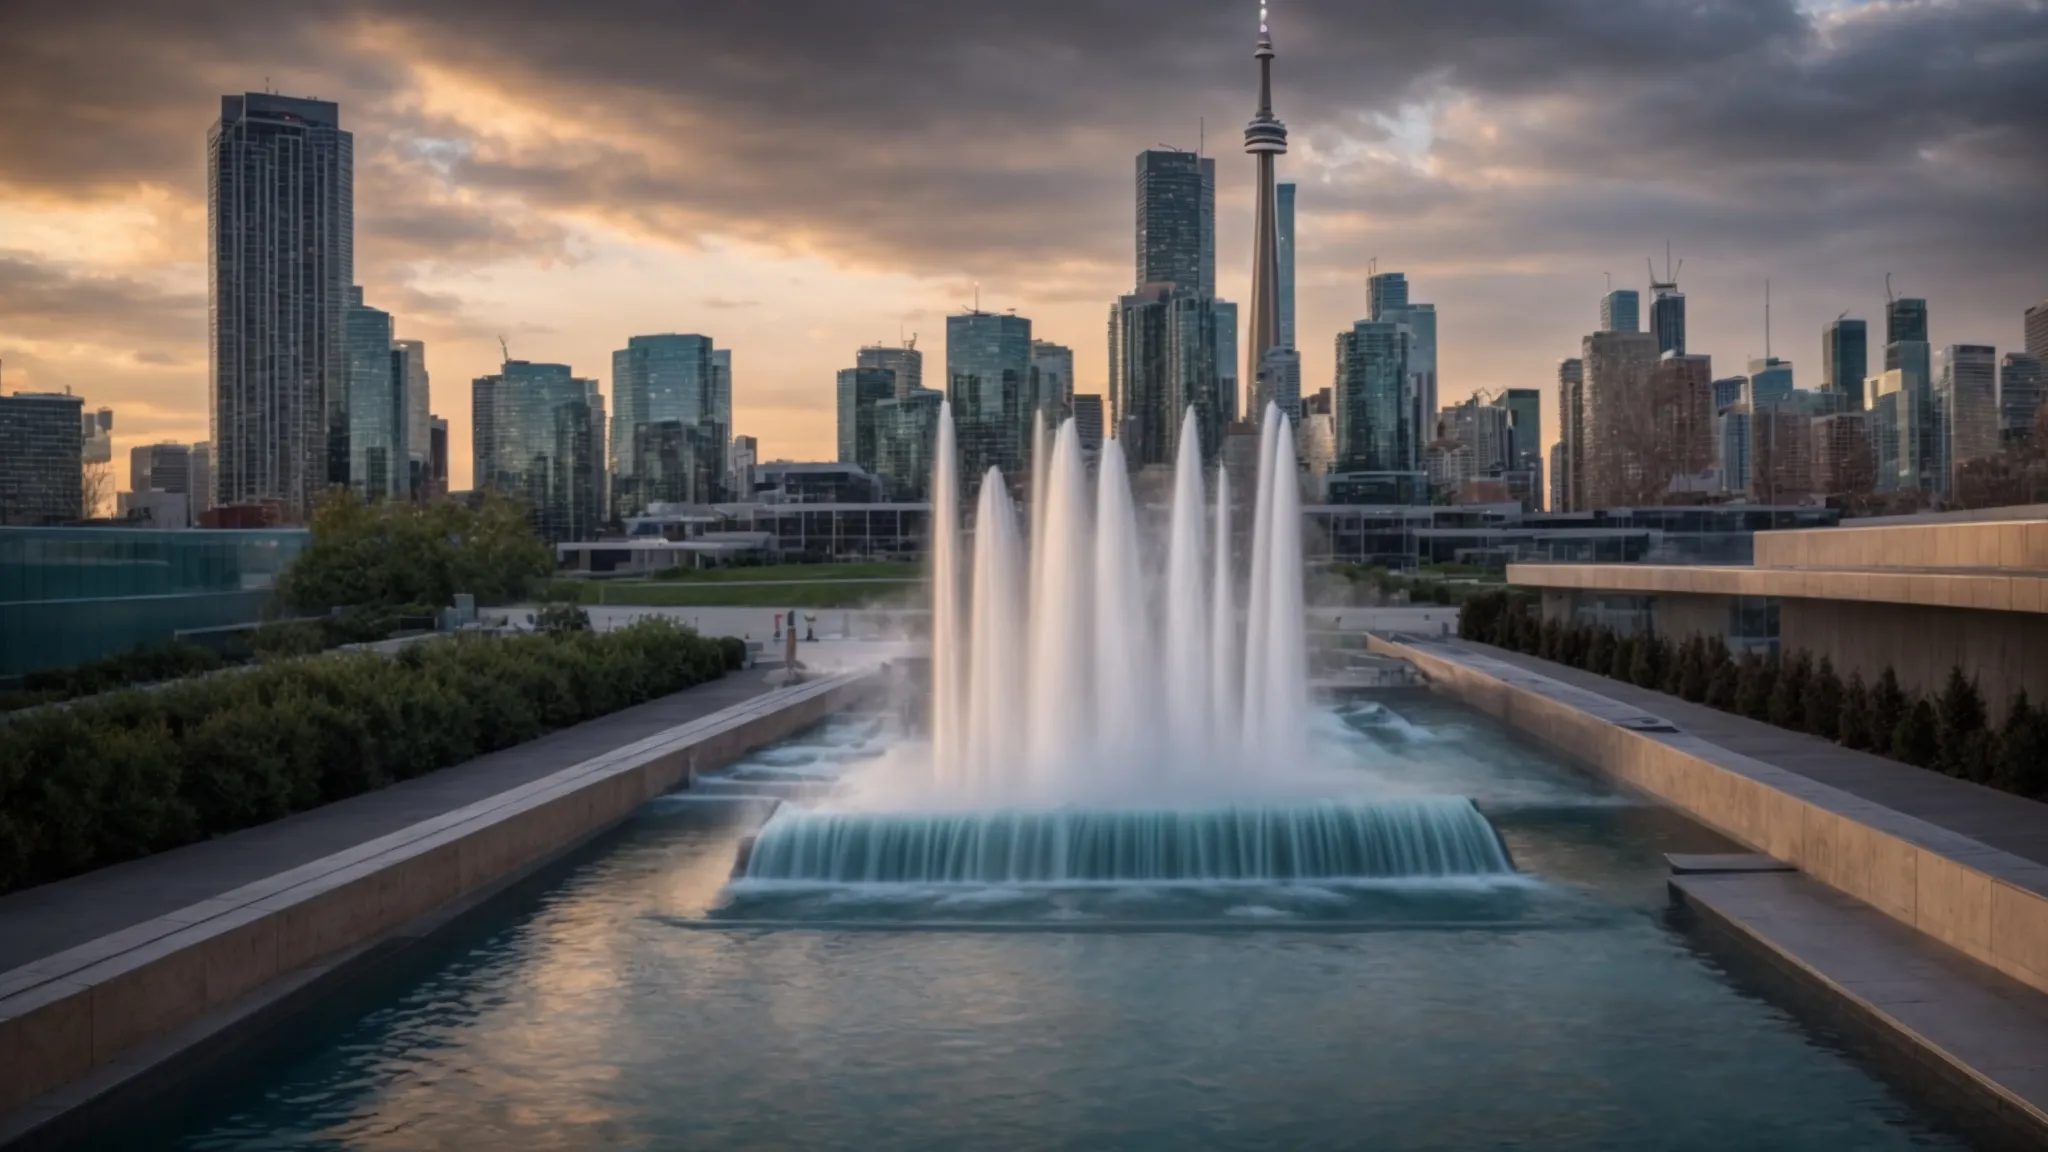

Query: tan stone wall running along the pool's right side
left=1370, top=635, right=2048, bottom=992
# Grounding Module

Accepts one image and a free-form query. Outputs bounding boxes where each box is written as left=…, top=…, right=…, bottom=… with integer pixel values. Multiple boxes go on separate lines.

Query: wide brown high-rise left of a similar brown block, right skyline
left=1575, top=332, right=1662, bottom=508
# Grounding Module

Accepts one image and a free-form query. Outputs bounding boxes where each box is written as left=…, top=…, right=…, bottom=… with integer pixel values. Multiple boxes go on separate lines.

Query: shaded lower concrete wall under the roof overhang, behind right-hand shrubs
left=1778, top=601, right=2048, bottom=722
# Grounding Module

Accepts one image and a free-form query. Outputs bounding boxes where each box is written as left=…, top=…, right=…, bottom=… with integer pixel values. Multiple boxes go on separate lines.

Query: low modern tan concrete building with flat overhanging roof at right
left=1507, top=506, right=2048, bottom=717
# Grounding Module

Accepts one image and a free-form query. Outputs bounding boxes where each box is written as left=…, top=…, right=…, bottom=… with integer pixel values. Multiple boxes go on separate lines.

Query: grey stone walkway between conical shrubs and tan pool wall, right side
left=1440, top=640, right=2048, bottom=865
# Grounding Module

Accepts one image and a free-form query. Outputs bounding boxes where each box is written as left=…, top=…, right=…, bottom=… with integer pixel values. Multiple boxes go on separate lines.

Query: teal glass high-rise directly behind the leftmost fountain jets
left=946, top=312, right=1030, bottom=485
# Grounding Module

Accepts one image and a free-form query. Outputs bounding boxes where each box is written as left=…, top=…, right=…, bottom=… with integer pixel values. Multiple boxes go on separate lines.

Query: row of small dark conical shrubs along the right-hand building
left=1458, top=590, right=2048, bottom=799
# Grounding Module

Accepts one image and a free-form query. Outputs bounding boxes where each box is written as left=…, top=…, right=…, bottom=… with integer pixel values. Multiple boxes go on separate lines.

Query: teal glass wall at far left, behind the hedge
left=0, top=529, right=311, bottom=676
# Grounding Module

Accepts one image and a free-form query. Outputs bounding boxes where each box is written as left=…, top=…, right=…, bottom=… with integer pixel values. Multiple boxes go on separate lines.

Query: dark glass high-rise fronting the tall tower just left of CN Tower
left=1110, top=283, right=1225, bottom=467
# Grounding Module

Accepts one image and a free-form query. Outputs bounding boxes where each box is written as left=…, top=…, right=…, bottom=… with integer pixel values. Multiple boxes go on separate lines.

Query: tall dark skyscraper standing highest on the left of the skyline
left=207, top=92, right=354, bottom=521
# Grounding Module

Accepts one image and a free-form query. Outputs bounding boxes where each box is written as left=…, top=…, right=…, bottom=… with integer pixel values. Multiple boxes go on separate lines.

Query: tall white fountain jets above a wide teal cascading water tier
left=741, top=406, right=1513, bottom=883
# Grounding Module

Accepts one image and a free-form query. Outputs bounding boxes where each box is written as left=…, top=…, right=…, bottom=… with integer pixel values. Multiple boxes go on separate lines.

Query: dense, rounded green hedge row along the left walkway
left=0, top=621, right=745, bottom=892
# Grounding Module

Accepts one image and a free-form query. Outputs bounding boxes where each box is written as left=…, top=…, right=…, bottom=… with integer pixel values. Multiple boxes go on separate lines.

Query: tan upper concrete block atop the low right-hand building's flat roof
left=1757, top=521, right=2048, bottom=572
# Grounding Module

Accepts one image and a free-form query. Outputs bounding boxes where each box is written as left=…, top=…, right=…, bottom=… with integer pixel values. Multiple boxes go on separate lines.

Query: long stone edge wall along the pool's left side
left=0, top=670, right=879, bottom=1146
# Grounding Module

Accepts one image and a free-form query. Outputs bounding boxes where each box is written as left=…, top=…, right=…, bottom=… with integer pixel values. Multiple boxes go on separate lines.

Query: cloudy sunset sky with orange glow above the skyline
left=0, top=0, right=2048, bottom=486
